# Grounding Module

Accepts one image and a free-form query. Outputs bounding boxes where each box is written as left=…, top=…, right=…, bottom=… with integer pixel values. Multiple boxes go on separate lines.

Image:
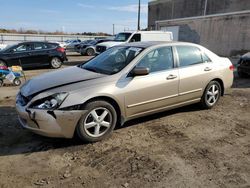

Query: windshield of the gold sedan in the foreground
left=81, top=46, right=143, bottom=75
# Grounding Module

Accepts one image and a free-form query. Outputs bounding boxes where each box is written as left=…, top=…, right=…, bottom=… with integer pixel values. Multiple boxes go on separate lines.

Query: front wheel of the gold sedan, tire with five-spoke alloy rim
left=76, top=101, right=117, bottom=143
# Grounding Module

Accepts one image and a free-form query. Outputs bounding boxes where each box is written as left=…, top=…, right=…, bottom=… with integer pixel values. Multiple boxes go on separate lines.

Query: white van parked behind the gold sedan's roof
left=96, top=31, right=173, bottom=54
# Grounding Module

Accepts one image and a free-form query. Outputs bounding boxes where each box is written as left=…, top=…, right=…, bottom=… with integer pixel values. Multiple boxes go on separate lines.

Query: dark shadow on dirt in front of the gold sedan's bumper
left=0, top=107, right=82, bottom=156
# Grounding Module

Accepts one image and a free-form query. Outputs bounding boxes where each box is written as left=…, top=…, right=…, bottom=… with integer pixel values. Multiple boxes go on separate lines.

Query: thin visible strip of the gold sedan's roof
left=119, top=41, right=195, bottom=48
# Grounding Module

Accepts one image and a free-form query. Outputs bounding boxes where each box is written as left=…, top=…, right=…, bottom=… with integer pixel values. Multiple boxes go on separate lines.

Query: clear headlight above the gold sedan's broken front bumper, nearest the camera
left=30, top=93, right=68, bottom=110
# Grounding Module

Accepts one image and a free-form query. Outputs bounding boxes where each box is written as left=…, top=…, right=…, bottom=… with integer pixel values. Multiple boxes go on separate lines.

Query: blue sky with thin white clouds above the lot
left=0, top=0, right=148, bottom=33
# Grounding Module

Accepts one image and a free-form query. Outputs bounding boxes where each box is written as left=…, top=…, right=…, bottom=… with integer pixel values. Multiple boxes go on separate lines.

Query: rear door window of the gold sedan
left=176, top=46, right=203, bottom=67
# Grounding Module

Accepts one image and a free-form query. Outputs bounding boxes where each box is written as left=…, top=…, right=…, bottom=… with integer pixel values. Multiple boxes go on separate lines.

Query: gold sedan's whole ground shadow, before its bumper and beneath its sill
left=0, top=105, right=201, bottom=156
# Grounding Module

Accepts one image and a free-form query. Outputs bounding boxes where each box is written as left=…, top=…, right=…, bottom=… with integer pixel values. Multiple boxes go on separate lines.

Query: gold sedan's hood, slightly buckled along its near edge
left=21, top=66, right=107, bottom=97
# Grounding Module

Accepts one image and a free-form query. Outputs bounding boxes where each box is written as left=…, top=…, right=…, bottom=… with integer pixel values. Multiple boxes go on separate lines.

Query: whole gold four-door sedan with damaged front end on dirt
left=16, top=42, right=234, bottom=142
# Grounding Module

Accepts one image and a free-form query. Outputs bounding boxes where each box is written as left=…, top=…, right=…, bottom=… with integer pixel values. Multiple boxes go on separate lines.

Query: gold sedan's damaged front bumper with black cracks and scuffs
left=16, top=103, right=86, bottom=138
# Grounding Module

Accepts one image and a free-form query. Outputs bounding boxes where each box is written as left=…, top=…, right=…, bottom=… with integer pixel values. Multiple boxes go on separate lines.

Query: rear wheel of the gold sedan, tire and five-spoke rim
left=201, top=81, right=221, bottom=109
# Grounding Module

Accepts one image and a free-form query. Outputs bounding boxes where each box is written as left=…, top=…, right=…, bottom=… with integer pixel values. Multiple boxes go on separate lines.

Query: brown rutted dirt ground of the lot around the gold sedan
left=0, top=55, right=250, bottom=188
